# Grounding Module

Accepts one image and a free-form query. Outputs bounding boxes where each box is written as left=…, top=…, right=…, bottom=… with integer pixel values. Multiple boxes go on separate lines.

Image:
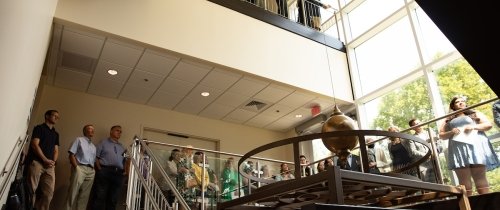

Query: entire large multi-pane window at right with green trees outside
left=328, top=0, right=500, bottom=192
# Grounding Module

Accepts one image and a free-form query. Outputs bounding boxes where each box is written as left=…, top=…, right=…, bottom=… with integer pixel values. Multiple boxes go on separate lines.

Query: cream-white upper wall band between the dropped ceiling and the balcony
left=55, top=0, right=353, bottom=102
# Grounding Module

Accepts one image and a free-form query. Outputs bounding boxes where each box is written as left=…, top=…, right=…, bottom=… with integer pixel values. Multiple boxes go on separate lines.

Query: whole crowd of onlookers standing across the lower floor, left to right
left=25, top=96, right=500, bottom=210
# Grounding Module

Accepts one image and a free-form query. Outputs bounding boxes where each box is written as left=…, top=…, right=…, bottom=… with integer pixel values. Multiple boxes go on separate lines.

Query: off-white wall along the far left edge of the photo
left=0, top=0, right=57, bottom=204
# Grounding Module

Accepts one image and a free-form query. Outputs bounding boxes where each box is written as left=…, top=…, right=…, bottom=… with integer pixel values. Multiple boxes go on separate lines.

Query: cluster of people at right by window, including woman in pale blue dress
left=380, top=96, right=500, bottom=195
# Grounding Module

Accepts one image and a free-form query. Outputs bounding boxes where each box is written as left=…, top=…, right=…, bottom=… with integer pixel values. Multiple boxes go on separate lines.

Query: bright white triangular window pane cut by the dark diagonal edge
left=412, top=8, right=455, bottom=63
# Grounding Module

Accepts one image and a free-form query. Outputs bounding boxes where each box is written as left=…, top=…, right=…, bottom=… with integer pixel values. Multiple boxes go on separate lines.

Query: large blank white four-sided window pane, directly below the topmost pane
left=355, top=17, right=419, bottom=94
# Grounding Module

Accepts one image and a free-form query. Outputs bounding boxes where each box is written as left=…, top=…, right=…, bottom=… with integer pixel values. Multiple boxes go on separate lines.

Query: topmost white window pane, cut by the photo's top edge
left=348, top=0, right=404, bottom=39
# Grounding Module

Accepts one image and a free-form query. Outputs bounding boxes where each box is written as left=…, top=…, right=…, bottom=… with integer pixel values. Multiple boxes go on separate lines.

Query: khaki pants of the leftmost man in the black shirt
left=29, top=160, right=56, bottom=210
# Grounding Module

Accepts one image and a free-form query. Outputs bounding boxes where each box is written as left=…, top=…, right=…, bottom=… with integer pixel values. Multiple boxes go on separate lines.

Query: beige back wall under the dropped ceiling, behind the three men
left=30, top=86, right=292, bottom=209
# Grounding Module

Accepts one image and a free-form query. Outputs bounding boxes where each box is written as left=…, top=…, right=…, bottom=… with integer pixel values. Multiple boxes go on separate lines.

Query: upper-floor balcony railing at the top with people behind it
left=208, top=0, right=346, bottom=52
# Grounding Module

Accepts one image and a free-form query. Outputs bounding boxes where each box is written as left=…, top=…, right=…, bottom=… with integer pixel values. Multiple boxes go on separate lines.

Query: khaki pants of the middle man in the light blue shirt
left=66, top=165, right=95, bottom=210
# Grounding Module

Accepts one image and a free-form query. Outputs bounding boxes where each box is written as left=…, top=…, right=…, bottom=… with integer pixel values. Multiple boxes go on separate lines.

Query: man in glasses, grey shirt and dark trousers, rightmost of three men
left=92, top=125, right=127, bottom=210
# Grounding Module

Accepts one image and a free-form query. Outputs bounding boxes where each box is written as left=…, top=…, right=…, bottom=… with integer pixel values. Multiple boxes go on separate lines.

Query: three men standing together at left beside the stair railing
left=25, top=110, right=128, bottom=210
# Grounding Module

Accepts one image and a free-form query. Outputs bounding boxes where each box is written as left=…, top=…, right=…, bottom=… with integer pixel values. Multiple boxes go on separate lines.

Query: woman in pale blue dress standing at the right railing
left=439, top=96, right=500, bottom=195
